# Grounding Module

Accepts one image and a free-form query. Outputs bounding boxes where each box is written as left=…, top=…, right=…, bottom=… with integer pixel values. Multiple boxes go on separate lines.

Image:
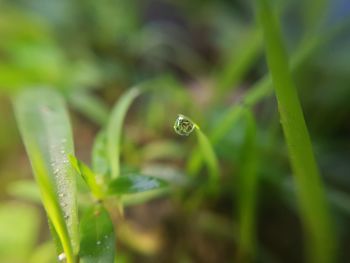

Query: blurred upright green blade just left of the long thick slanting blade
left=237, top=110, right=258, bottom=262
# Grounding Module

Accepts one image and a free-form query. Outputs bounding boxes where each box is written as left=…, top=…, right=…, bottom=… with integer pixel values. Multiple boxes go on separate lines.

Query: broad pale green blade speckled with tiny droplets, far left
left=14, top=88, right=79, bottom=263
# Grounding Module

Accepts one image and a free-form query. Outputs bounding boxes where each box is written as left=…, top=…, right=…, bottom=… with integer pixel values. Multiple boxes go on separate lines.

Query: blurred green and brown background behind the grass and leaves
left=0, top=0, right=350, bottom=263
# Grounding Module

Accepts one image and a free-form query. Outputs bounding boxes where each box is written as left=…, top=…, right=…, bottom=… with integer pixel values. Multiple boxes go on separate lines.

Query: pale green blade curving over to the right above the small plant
left=106, top=88, right=141, bottom=178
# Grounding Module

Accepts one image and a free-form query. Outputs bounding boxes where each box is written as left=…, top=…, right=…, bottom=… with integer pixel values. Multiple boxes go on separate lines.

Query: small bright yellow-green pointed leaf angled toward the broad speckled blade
left=69, top=155, right=104, bottom=200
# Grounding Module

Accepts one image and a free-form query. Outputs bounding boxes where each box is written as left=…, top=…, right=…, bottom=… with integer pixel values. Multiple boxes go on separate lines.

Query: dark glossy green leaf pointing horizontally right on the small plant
left=108, top=174, right=168, bottom=195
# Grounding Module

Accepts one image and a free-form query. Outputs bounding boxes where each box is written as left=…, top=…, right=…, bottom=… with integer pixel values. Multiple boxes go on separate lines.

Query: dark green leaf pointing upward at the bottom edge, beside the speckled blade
left=79, top=205, right=116, bottom=263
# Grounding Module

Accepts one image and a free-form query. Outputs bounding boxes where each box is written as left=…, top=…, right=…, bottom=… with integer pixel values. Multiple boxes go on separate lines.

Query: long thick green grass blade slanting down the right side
left=257, top=0, right=336, bottom=263
